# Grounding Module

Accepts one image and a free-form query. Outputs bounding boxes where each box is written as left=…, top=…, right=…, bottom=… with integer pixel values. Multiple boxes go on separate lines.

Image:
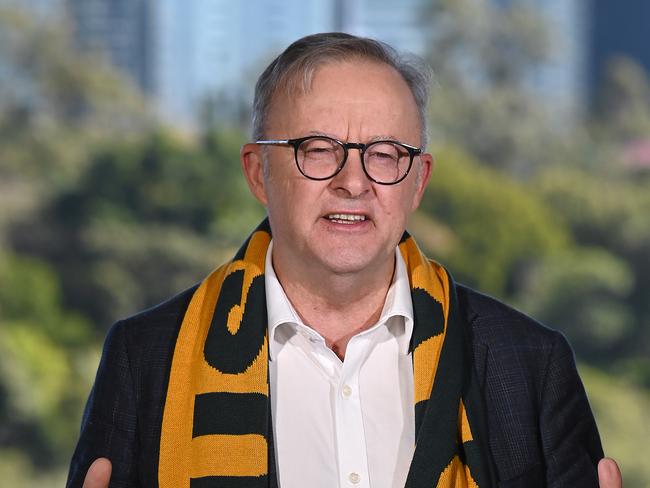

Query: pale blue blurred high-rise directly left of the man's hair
left=152, top=0, right=332, bottom=122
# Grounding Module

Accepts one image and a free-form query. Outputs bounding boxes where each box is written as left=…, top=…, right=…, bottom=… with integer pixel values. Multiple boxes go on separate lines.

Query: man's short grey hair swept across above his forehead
left=253, top=32, right=432, bottom=147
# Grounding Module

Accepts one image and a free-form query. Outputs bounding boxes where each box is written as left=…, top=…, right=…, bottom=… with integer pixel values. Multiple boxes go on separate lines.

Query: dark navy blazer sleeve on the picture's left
left=66, top=322, right=139, bottom=488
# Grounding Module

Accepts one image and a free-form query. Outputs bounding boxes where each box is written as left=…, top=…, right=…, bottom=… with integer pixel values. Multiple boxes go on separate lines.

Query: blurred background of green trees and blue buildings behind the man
left=0, top=0, right=650, bottom=488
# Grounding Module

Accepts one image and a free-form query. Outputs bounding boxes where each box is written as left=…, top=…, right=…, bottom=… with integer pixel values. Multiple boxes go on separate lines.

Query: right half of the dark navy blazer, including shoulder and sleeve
left=457, top=285, right=603, bottom=488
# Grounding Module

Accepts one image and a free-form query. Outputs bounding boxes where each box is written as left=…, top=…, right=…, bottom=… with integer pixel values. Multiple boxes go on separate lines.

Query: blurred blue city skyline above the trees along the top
left=5, top=0, right=650, bottom=132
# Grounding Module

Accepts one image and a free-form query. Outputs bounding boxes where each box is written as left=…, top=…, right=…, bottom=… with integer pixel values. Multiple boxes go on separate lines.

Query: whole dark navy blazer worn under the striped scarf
left=67, top=285, right=603, bottom=488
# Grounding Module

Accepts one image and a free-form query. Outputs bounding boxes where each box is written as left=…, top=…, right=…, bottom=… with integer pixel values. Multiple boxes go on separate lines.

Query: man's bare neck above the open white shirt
left=273, top=253, right=395, bottom=359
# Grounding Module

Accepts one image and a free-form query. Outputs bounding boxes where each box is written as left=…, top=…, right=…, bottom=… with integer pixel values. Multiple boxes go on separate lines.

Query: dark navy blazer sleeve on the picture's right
left=539, top=333, right=603, bottom=488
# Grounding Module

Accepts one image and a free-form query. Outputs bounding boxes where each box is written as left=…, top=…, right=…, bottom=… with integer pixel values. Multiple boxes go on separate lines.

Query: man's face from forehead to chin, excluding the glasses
left=242, top=60, right=432, bottom=280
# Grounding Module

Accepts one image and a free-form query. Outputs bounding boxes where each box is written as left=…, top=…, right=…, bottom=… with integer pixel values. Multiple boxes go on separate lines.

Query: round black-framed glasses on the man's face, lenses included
left=255, top=136, right=422, bottom=185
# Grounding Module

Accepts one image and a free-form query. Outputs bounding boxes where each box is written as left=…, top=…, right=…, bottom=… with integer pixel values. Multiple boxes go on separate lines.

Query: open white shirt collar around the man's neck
left=264, top=240, right=413, bottom=360
